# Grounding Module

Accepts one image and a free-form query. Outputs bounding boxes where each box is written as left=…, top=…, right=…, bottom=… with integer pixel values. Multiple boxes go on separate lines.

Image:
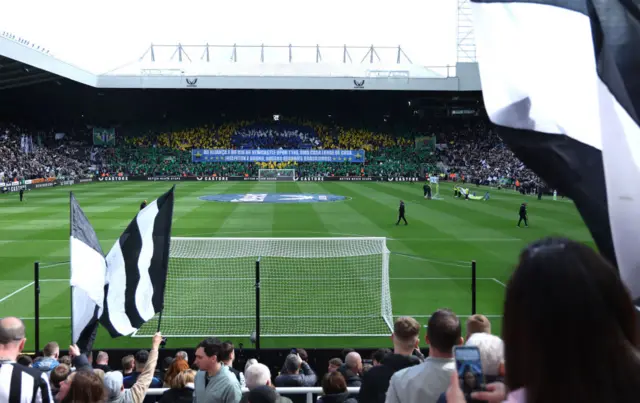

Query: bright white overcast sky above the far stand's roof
left=0, top=0, right=457, bottom=73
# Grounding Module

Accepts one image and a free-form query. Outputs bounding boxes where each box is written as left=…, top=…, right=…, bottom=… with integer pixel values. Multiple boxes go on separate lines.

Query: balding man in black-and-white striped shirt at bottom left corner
left=0, top=317, right=53, bottom=403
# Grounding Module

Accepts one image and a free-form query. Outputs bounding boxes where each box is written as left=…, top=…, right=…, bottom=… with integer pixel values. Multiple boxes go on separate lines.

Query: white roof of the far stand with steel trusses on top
left=0, top=37, right=480, bottom=91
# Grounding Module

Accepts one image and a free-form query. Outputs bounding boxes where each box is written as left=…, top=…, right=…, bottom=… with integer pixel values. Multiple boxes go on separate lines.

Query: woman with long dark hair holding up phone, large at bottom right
left=447, top=238, right=640, bottom=403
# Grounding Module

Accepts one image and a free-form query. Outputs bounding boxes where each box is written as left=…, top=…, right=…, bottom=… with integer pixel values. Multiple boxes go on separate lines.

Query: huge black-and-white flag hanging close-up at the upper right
left=472, top=0, right=640, bottom=298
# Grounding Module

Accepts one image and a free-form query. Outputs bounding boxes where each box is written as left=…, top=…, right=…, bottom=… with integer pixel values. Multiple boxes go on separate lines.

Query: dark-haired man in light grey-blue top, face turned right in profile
left=193, top=337, right=242, bottom=403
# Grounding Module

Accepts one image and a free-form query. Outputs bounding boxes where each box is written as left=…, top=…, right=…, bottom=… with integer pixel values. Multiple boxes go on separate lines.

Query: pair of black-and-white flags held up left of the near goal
left=71, top=186, right=175, bottom=351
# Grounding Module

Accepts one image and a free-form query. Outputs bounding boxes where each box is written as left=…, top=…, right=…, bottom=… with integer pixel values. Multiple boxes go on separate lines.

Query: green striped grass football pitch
left=0, top=182, right=593, bottom=349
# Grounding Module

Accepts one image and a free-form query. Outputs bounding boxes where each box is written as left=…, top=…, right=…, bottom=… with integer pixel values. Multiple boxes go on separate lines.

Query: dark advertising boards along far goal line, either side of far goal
left=93, top=176, right=422, bottom=182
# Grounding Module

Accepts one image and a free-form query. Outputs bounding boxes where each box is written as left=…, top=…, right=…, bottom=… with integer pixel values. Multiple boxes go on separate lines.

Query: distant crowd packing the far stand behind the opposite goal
left=0, top=119, right=541, bottom=188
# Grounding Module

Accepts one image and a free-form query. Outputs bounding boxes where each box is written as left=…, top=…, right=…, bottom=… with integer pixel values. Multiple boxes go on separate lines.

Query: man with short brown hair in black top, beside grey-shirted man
left=358, top=316, right=420, bottom=403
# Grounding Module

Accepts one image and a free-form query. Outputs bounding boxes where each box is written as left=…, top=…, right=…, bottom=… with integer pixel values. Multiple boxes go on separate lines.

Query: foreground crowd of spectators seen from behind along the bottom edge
left=0, top=238, right=640, bottom=403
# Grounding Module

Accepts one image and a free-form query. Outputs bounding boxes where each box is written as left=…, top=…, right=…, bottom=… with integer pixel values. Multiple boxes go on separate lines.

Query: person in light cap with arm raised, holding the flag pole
left=104, top=333, right=162, bottom=403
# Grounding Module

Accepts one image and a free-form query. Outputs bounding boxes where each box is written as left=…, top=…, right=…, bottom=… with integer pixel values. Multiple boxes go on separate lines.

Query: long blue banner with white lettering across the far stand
left=191, top=149, right=364, bottom=163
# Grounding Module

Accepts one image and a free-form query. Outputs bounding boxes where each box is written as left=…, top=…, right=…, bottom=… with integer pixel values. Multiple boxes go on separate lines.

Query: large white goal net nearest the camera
left=135, top=238, right=393, bottom=337
